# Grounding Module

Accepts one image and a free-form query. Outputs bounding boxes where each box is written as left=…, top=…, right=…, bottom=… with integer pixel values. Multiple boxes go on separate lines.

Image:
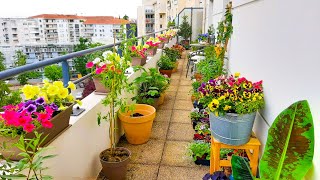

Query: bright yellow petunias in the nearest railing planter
left=22, top=80, right=81, bottom=111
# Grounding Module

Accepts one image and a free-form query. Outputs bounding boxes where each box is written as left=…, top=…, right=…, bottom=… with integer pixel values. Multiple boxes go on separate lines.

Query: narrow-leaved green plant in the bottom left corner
left=0, top=132, right=56, bottom=180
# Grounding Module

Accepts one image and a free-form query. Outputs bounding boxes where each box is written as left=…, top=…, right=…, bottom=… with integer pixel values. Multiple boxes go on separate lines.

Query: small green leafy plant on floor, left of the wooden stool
left=188, top=143, right=211, bottom=161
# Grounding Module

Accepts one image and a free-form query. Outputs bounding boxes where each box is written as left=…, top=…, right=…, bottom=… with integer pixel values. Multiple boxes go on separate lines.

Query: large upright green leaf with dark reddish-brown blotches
left=260, top=100, right=314, bottom=180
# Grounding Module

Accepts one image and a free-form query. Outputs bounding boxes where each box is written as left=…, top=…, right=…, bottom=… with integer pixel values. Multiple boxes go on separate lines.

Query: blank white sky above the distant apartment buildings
left=0, top=0, right=141, bottom=18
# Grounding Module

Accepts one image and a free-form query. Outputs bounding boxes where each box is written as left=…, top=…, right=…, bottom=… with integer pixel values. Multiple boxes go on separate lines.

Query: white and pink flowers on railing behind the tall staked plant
left=86, top=51, right=129, bottom=75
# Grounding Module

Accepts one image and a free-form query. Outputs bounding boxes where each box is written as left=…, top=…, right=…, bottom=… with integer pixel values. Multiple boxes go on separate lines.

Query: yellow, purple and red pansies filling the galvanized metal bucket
left=198, top=73, right=264, bottom=116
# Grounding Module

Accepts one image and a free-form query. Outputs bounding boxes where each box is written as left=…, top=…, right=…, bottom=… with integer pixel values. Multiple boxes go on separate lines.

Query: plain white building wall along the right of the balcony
left=213, top=0, right=320, bottom=179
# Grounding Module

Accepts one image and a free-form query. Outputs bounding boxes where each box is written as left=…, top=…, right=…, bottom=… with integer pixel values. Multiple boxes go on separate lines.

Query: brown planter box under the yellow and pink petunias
left=0, top=104, right=73, bottom=161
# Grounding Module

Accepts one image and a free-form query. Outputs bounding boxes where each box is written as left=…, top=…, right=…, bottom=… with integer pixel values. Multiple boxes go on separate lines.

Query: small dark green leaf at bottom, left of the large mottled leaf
left=231, top=155, right=254, bottom=180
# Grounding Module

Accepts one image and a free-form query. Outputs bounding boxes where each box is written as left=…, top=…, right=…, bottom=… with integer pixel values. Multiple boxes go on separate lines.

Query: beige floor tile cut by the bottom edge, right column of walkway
left=158, top=166, right=210, bottom=180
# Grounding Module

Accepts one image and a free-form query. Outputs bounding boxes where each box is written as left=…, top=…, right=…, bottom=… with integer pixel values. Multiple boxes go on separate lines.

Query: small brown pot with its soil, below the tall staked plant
left=99, top=147, right=131, bottom=180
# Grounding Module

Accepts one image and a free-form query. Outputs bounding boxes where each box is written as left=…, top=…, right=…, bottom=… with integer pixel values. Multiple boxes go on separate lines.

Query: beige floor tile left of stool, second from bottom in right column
left=161, top=141, right=196, bottom=167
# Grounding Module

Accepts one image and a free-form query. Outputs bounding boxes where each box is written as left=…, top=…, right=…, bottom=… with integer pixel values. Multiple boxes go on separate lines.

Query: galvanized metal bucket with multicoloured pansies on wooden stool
left=199, top=73, right=264, bottom=145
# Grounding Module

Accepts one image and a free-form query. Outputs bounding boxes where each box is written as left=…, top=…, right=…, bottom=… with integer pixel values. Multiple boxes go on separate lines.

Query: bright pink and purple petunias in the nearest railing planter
left=0, top=97, right=58, bottom=133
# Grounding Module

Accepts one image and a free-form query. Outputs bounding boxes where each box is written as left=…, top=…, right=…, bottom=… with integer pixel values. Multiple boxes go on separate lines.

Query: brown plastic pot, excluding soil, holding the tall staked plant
left=99, top=147, right=131, bottom=180
